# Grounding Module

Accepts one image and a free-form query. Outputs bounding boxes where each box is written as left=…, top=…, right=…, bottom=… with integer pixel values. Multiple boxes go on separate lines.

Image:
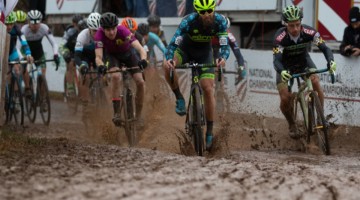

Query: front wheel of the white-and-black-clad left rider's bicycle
left=37, top=75, right=51, bottom=126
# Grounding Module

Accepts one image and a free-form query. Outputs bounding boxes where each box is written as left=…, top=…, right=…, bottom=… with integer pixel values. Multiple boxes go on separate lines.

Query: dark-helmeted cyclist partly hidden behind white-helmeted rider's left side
left=60, top=14, right=85, bottom=97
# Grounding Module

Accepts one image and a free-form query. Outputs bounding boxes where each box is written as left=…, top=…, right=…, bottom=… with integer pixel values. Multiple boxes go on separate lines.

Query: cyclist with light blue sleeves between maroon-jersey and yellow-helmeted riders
left=136, top=23, right=166, bottom=65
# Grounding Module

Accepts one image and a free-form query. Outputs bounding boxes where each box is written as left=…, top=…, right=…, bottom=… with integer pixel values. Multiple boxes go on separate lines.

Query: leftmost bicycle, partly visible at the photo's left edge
left=5, top=61, right=24, bottom=125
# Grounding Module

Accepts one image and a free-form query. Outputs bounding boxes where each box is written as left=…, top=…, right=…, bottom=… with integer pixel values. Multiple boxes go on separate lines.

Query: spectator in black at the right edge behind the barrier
left=340, top=7, right=360, bottom=56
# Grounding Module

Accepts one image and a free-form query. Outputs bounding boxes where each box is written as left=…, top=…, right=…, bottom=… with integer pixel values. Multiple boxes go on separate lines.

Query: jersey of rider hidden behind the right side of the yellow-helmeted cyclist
left=211, top=30, right=244, bottom=66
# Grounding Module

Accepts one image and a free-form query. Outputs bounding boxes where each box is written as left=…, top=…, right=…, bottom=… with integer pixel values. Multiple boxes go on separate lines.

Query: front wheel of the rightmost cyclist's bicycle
left=310, top=91, right=330, bottom=155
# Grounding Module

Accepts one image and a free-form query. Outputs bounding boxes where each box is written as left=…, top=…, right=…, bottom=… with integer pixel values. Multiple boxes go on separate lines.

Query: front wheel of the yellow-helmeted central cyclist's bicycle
left=190, top=87, right=204, bottom=156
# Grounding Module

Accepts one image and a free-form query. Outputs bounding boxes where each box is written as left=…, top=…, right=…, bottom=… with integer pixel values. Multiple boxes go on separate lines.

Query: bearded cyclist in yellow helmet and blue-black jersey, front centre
left=164, top=0, right=230, bottom=150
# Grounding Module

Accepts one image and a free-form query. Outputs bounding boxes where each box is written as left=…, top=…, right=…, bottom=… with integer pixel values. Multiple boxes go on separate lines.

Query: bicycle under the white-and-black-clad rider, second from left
left=13, top=60, right=57, bottom=126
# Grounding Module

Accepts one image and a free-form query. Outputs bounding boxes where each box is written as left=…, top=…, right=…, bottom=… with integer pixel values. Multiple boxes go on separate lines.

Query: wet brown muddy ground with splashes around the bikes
left=0, top=73, right=360, bottom=200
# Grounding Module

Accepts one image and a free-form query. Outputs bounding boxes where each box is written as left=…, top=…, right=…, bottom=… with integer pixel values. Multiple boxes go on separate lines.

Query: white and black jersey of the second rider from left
left=21, top=23, right=58, bottom=60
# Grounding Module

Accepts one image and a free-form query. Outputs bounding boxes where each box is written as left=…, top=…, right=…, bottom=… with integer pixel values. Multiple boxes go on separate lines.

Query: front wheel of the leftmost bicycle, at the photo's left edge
left=9, top=76, right=24, bottom=125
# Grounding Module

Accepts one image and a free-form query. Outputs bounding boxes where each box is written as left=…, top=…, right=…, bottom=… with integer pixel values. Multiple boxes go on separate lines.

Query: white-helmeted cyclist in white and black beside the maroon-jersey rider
left=74, top=12, right=101, bottom=113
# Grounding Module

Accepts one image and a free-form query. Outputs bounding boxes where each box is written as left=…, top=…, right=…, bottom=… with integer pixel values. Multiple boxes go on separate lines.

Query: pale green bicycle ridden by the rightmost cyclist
left=288, top=68, right=335, bottom=155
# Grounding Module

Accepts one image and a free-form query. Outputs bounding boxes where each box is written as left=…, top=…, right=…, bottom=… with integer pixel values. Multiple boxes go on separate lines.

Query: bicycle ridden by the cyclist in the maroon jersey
left=106, top=63, right=143, bottom=147
